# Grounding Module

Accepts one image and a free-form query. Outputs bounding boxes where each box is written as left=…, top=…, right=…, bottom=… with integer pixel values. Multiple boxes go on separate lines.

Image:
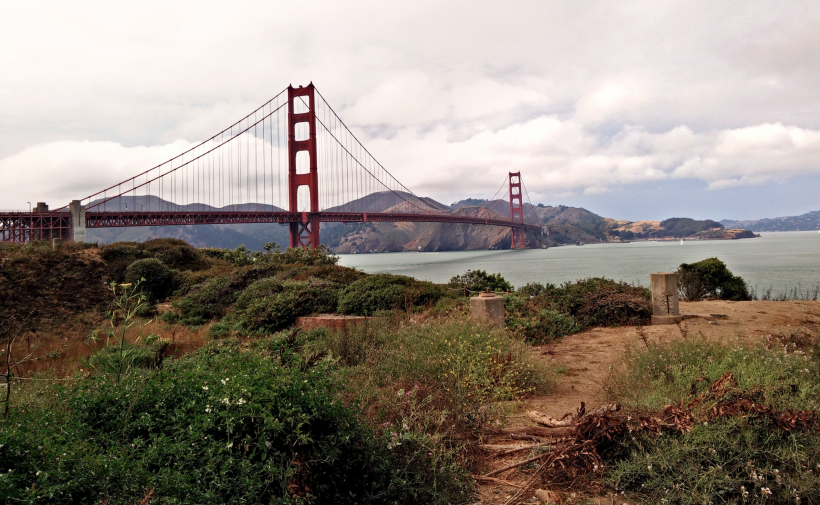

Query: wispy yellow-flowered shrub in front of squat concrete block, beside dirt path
left=308, top=316, right=549, bottom=428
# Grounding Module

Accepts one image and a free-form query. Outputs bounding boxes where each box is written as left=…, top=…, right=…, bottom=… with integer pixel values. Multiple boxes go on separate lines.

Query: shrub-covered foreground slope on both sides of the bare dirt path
left=0, top=239, right=820, bottom=505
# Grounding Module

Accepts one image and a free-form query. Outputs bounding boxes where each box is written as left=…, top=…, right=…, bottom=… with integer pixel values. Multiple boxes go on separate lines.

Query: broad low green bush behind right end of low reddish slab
left=339, top=274, right=445, bottom=316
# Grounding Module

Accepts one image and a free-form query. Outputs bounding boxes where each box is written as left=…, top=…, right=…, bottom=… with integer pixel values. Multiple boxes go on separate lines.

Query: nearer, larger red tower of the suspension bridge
left=288, top=82, right=319, bottom=249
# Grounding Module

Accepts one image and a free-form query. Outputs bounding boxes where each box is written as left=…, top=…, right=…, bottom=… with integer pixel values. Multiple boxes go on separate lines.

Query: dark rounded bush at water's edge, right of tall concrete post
left=678, top=258, right=751, bottom=301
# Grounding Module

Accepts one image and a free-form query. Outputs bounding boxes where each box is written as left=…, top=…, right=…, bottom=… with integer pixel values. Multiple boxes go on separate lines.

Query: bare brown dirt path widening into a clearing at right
left=478, top=301, right=820, bottom=505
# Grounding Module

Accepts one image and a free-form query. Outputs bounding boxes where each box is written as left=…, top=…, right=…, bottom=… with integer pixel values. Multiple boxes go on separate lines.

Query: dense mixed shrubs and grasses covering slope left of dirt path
left=0, top=240, right=548, bottom=504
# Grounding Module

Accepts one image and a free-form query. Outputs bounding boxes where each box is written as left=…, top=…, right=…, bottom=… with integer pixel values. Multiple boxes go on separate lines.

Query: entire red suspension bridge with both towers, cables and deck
left=0, top=83, right=541, bottom=249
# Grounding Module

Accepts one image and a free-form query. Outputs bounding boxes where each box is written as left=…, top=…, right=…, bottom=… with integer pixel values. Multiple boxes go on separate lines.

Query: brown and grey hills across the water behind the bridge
left=80, top=191, right=754, bottom=253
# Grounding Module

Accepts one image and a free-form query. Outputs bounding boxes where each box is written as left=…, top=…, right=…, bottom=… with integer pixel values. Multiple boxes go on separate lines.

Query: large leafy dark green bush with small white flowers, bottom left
left=0, top=340, right=468, bottom=505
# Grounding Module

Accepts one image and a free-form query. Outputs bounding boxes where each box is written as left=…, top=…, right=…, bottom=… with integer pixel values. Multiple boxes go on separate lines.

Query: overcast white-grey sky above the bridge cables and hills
left=0, top=0, right=820, bottom=220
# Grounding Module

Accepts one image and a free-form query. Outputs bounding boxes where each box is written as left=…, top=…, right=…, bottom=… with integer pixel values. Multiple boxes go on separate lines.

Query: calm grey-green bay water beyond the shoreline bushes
left=340, top=231, right=820, bottom=292
